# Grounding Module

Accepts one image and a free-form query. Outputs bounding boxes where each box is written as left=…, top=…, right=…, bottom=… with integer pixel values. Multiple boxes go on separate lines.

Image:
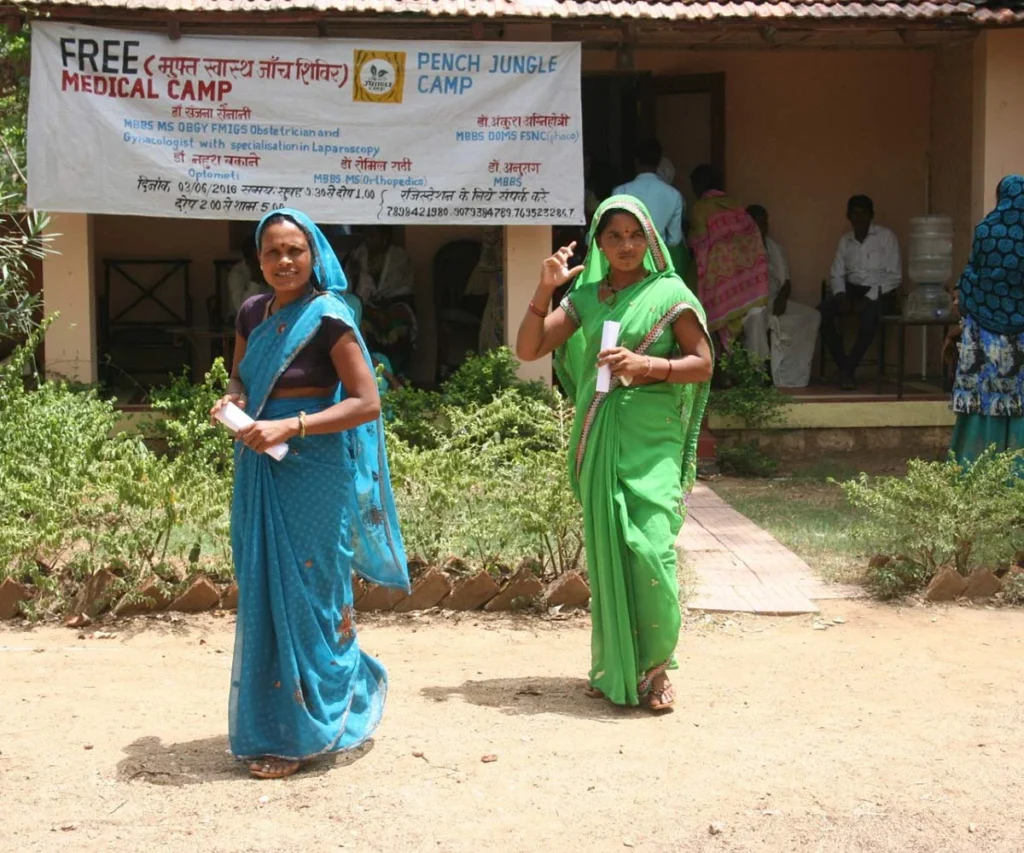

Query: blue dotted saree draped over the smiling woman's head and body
left=229, top=210, right=409, bottom=760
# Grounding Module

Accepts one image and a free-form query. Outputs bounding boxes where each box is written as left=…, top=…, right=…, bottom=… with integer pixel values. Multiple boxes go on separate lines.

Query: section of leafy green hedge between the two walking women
left=388, top=387, right=583, bottom=574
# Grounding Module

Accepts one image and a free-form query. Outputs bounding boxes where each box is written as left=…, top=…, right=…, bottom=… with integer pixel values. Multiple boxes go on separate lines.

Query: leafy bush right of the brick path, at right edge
left=843, top=451, right=1024, bottom=588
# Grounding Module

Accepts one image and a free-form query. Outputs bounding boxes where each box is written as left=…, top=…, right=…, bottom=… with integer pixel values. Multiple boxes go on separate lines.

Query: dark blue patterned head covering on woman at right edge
left=958, top=175, right=1024, bottom=335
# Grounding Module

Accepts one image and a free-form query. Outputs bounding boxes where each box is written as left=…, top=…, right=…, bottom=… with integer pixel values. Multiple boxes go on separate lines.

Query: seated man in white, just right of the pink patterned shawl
left=743, top=205, right=821, bottom=388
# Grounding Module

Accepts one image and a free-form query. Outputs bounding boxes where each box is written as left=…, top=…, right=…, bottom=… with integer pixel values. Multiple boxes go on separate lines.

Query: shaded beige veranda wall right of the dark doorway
left=584, top=50, right=932, bottom=303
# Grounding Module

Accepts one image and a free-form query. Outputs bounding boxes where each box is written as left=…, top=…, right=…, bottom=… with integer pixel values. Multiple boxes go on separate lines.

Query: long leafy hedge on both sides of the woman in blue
left=0, top=330, right=584, bottom=614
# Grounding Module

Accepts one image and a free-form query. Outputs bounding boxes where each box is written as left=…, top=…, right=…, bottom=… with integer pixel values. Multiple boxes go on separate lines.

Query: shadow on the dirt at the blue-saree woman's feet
left=118, top=735, right=374, bottom=787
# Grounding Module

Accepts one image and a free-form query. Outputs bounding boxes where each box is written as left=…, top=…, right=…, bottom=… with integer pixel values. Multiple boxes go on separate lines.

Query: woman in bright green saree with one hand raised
left=516, top=196, right=714, bottom=711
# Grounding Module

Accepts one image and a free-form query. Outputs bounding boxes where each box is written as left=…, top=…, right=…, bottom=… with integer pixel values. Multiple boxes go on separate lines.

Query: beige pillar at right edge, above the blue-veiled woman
left=966, top=30, right=1024, bottom=222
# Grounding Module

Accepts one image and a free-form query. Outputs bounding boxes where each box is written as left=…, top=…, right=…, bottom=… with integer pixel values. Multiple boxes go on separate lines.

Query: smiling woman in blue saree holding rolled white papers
left=211, top=210, right=409, bottom=778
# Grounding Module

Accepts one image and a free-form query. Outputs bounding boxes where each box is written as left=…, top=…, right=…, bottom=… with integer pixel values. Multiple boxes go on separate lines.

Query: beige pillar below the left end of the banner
left=43, top=213, right=98, bottom=384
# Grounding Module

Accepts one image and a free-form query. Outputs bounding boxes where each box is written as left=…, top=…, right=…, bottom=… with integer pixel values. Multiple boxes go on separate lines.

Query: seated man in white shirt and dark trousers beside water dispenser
left=818, top=196, right=903, bottom=391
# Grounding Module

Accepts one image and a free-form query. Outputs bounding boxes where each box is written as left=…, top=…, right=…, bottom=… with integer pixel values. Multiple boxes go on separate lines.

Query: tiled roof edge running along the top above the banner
left=9, top=0, right=1024, bottom=26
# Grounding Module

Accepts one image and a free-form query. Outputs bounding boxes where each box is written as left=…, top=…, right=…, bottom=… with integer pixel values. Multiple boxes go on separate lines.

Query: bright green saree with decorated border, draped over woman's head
left=555, top=196, right=711, bottom=706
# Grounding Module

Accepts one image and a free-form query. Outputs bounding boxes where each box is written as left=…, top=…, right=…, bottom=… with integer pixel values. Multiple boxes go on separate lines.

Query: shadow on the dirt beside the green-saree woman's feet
left=423, top=677, right=645, bottom=721
